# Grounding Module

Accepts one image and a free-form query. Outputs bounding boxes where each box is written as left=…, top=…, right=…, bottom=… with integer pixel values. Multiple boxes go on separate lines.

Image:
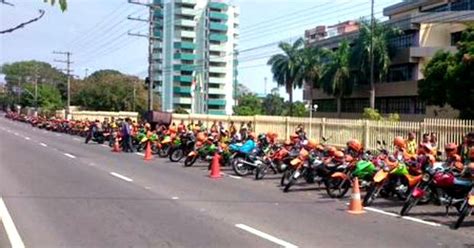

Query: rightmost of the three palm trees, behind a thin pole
left=351, top=17, right=400, bottom=108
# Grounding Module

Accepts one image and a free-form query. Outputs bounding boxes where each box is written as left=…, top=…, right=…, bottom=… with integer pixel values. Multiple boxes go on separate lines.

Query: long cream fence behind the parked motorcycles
left=173, top=114, right=474, bottom=149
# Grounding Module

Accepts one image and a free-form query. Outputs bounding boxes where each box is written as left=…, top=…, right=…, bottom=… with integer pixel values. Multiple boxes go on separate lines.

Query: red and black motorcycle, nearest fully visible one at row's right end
left=400, top=163, right=473, bottom=216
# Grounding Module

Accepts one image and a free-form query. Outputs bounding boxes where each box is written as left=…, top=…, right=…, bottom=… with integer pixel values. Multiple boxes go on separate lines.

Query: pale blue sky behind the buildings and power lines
left=0, top=0, right=399, bottom=100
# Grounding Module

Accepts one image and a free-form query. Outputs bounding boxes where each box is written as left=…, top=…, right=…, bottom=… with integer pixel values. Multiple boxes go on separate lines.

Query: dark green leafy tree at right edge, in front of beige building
left=418, top=26, right=474, bottom=119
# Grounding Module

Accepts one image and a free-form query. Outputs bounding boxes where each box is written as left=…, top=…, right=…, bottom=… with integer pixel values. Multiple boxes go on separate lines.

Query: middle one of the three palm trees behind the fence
left=321, top=41, right=354, bottom=117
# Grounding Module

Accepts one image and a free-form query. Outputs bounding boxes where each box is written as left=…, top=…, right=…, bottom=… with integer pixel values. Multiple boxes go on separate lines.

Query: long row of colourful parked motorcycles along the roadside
left=7, top=111, right=474, bottom=229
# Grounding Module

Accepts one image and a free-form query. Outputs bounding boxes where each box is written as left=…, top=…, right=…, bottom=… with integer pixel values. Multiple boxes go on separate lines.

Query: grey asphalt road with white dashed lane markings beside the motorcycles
left=0, top=117, right=474, bottom=247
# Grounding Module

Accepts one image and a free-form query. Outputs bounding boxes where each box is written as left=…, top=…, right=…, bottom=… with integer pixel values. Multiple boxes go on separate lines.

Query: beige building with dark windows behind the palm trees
left=304, top=0, right=474, bottom=119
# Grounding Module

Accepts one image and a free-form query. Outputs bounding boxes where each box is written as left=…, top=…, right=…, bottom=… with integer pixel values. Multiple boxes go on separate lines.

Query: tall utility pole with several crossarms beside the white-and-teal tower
left=127, top=0, right=161, bottom=111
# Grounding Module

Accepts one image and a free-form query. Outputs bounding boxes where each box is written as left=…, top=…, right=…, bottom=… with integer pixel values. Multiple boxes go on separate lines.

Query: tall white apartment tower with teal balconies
left=152, top=0, right=239, bottom=115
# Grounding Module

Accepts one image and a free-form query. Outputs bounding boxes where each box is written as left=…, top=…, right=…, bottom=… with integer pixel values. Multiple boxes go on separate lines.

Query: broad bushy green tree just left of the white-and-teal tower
left=71, top=70, right=159, bottom=112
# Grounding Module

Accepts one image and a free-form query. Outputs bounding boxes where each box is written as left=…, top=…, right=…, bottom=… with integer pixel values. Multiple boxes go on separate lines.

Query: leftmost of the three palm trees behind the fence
left=267, top=38, right=304, bottom=116
